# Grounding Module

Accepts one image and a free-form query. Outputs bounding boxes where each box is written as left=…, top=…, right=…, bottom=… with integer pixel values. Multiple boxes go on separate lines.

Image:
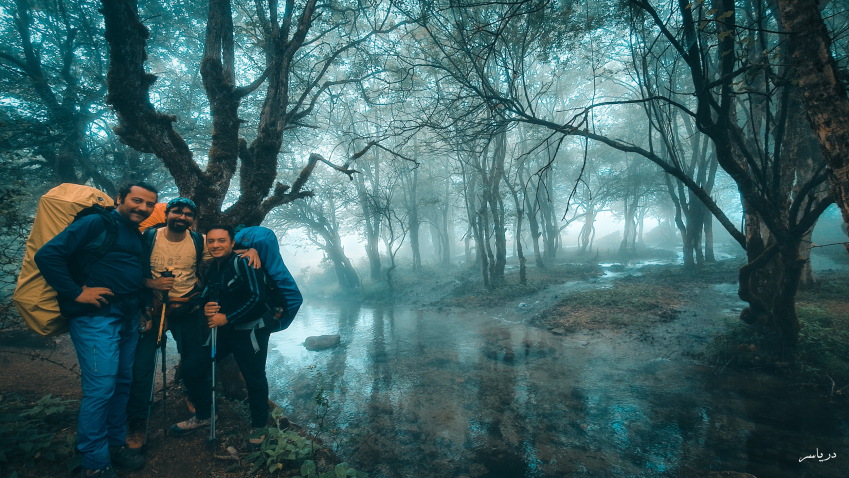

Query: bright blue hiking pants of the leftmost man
left=69, top=314, right=139, bottom=470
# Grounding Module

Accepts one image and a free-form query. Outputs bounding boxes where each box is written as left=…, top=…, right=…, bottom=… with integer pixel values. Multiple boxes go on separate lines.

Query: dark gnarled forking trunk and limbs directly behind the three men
left=102, top=0, right=323, bottom=227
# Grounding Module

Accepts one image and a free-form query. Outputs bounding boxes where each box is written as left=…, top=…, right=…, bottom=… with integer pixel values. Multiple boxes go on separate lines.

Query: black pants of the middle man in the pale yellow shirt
left=127, top=311, right=210, bottom=423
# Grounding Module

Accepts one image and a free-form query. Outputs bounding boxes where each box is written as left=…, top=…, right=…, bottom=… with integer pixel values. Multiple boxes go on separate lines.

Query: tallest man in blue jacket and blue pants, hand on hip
left=35, top=182, right=158, bottom=477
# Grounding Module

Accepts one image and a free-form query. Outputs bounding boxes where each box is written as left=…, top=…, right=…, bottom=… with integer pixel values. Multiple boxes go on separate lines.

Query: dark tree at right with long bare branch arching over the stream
left=398, top=0, right=832, bottom=356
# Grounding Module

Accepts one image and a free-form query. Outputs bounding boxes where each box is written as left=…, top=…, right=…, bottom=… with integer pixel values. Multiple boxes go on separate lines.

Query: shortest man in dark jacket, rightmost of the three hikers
left=169, top=226, right=271, bottom=443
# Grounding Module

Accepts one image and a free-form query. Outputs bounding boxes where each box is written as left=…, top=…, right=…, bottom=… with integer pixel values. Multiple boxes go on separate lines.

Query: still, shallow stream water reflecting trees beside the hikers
left=268, top=298, right=849, bottom=477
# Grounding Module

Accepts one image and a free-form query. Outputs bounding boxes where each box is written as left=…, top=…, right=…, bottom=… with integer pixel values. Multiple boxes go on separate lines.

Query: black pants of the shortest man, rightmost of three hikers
left=182, top=326, right=271, bottom=427
